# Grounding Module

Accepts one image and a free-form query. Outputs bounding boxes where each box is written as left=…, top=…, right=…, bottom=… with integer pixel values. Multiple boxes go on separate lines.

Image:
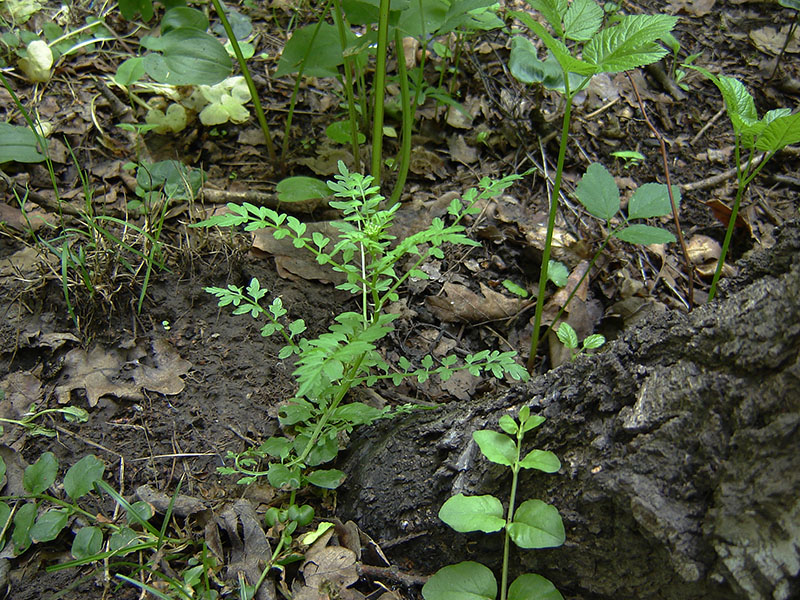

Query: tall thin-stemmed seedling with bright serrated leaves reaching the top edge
left=509, top=0, right=677, bottom=371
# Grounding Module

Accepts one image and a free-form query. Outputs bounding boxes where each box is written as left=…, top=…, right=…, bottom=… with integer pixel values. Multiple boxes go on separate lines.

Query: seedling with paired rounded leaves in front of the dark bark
left=422, top=406, right=566, bottom=600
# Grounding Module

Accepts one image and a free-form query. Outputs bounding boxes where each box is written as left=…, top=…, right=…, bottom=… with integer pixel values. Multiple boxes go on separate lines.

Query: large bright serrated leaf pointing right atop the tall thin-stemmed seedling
left=583, top=15, right=678, bottom=73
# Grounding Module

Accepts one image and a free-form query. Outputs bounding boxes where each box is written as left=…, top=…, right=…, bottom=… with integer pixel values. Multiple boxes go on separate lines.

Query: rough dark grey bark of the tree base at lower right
left=339, top=223, right=800, bottom=600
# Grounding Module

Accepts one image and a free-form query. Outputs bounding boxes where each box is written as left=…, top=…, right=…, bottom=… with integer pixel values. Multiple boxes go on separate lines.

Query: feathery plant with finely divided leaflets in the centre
left=198, top=162, right=526, bottom=491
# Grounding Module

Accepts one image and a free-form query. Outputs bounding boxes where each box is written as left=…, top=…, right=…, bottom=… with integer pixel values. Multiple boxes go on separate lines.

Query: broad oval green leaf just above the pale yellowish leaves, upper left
left=141, top=27, right=232, bottom=85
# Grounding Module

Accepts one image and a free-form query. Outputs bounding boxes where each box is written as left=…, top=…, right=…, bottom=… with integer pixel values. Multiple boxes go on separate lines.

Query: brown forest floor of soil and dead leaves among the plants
left=0, top=0, right=800, bottom=600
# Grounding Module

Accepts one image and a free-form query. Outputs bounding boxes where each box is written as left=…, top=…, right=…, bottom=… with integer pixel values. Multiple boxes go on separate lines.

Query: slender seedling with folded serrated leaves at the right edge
left=687, top=65, right=800, bottom=302
